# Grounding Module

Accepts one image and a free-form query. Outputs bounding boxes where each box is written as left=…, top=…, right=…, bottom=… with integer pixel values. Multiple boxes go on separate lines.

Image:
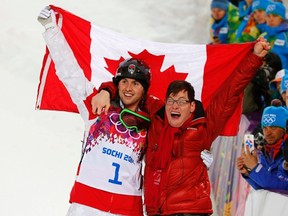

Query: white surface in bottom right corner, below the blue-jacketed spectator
left=244, top=190, right=288, bottom=216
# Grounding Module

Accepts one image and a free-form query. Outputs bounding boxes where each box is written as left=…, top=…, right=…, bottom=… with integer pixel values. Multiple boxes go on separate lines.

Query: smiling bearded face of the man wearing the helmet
left=118, top=78, right=145, bottom=111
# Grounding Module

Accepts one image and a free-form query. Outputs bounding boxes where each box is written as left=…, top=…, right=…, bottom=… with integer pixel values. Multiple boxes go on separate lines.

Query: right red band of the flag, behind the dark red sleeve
left=201, top=43, right=254, bottom=136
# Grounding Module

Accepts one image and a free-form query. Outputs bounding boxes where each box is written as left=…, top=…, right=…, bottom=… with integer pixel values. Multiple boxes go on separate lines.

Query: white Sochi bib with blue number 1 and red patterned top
left=76, top=113, right=146, bottom=196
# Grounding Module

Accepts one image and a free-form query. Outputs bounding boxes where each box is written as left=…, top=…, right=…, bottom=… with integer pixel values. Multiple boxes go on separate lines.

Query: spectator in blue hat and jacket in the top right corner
left=261, top=1, right=288, bottom=69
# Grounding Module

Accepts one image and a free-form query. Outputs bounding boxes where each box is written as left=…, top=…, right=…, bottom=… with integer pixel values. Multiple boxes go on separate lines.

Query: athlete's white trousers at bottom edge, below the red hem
left=66, top=203, right=119, bottom=216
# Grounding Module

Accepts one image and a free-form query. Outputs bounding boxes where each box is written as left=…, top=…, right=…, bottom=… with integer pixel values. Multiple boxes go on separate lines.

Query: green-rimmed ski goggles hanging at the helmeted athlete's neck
left=119, top=109, right=150, bottom=133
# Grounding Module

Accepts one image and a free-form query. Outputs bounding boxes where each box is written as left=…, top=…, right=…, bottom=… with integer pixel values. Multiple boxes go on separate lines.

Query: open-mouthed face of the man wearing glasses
left=165, top=90, right=195, bottom=127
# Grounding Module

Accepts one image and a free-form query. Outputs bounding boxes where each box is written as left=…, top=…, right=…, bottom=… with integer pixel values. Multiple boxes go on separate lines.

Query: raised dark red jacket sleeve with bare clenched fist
left=206, top=38, right=271, bottom=142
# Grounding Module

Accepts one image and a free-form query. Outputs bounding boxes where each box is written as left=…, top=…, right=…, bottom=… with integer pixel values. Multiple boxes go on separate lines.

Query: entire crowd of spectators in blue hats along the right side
left=209, top=0, right=288, bottom=197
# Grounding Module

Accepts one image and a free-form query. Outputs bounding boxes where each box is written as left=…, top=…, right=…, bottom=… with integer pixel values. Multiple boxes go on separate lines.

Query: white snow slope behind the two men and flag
left=0, top=0, right=288, bottom=216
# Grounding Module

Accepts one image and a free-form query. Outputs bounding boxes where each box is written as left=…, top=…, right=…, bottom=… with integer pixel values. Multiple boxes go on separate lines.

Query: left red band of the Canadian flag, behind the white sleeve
left=36, top=5, right=92, bottom=113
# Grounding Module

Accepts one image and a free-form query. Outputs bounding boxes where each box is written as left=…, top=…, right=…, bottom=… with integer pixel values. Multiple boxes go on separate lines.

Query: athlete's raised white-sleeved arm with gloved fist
left=38, top=6, right=95, bottom=122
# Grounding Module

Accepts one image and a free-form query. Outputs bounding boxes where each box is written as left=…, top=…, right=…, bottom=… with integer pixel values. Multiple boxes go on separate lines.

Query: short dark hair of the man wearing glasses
left=166, top=80, right=195, bottom=101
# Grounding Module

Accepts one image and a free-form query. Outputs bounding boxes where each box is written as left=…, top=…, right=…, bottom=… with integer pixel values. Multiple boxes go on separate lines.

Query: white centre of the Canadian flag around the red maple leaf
left=90, top=23, right=207, bottom=99
